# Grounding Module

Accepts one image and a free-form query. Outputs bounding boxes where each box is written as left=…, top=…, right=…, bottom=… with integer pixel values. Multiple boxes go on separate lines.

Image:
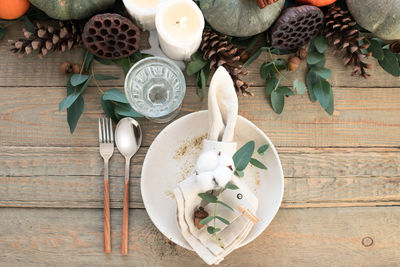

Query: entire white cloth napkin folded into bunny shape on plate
left=174, top=67, right=258, bottom=265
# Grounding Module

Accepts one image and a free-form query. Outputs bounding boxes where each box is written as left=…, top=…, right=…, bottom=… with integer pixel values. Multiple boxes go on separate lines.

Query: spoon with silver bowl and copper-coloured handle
left=115, top=118, right=142, bottom=255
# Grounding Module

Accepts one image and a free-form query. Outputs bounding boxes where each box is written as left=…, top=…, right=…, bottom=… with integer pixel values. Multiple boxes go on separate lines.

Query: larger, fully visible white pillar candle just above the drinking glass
left=156, top=0, right=204, bottom=60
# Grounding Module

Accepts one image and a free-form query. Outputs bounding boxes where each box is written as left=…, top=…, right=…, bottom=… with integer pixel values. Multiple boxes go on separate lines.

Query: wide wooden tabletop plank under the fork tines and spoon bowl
left=0, top=87, right=400, bottom=147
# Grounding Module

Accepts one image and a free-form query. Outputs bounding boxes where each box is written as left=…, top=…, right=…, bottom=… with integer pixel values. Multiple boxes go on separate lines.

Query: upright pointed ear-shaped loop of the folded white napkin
left=208, top=66, right=238, bottom=142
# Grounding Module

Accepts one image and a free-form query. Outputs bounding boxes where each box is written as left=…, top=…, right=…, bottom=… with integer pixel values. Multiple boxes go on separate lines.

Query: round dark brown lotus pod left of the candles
left=82, top=13, right=140, bottom=59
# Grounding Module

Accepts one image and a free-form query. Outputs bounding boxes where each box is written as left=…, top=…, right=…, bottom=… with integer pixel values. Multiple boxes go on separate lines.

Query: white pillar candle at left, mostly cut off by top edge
left=123, top=0, right=167, bottom=30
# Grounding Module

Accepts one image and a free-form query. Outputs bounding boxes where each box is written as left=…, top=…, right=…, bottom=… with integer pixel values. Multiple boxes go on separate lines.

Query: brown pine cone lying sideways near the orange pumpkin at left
left=8, top=21, right=82, bottom=57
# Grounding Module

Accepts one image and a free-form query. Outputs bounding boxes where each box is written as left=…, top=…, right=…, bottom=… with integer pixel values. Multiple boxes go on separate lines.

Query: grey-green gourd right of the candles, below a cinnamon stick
left=199, top=0, right=285, bottom=37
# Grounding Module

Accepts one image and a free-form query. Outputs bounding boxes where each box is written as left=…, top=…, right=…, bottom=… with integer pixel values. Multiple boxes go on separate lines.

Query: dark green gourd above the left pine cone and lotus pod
left=30, top=0, right=115, bottom=20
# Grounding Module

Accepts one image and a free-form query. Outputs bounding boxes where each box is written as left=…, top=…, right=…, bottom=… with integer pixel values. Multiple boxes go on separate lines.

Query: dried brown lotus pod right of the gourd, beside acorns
left=271, top=5, right=324, bottom=50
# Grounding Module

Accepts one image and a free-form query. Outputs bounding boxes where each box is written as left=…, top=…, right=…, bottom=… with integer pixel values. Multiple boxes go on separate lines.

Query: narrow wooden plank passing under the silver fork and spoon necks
left=0, top=146, right=400, bottom=178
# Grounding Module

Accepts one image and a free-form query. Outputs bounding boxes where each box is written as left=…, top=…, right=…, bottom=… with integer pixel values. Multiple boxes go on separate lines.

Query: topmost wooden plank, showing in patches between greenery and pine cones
left=0, top=24, right=400, bottom=88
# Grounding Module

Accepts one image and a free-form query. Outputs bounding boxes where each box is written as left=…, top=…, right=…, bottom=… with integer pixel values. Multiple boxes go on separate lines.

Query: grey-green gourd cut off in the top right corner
left=346, top=0, right=400, bottom=40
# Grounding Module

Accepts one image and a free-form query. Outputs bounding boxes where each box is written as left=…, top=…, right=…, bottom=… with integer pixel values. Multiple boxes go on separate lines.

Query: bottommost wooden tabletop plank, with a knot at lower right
left=0, top=207, right=400, bottom=266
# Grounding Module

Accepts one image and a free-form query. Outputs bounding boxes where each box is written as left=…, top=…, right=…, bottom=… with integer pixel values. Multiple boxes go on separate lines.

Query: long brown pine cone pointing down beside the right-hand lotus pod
left=325, top=5, right=371, bottom=78
